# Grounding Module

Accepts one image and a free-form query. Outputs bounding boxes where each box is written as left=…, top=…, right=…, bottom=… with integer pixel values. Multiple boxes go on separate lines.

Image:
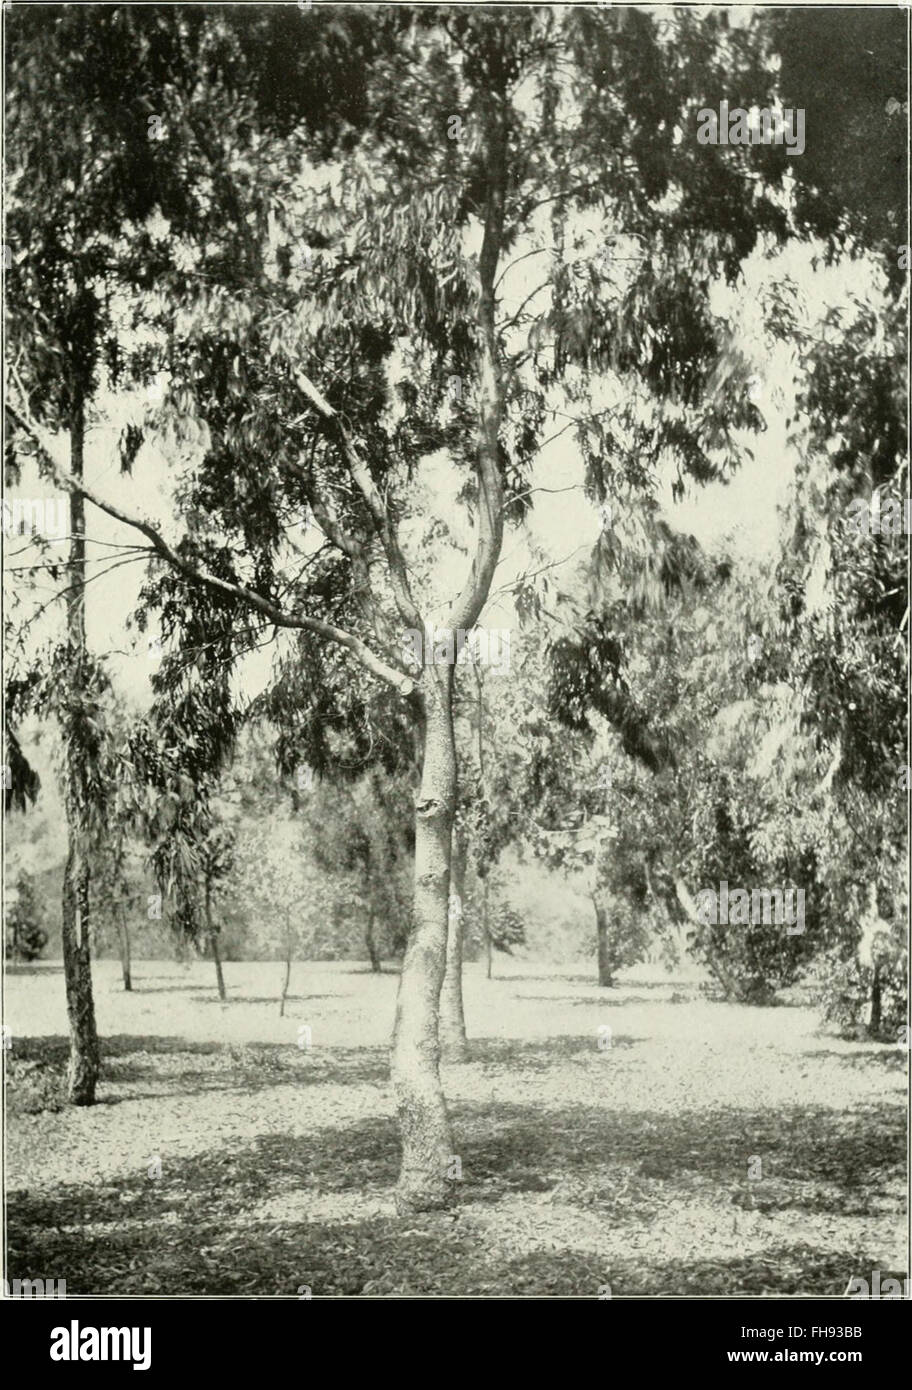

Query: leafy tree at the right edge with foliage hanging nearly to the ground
left=750, top=7, right=911, bottom=1037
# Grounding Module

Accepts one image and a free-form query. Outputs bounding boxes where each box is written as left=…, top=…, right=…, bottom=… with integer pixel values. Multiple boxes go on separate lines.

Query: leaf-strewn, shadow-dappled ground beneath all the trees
left=6, top=962, right=908, bottom=1297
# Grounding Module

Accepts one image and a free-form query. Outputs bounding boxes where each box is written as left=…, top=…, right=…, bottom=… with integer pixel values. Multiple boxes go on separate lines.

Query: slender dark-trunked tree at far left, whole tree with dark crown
left=4, top=6, right=246, bottom=1105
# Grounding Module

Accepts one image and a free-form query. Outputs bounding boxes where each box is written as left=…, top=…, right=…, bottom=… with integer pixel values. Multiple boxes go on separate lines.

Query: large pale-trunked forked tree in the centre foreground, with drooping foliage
left=7, top=7, right=788, bottom=1209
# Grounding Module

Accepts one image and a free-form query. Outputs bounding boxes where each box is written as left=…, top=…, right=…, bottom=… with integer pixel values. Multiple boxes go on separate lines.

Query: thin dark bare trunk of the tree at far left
left=61, top=399, right=100, bottom=1105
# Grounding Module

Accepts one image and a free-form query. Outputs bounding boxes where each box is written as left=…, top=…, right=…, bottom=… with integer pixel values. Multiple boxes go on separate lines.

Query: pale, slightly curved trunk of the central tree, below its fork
left=391, top=664, right=456, bottom=1212
